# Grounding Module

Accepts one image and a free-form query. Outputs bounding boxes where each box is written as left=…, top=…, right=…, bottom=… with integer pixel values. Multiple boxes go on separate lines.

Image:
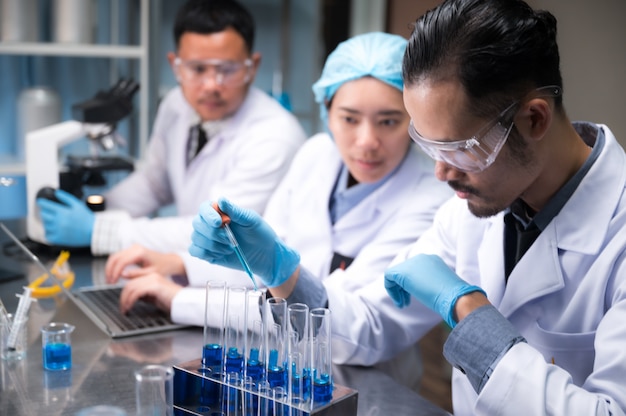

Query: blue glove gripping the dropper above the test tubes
left=189, top=198, right=300, bottom=288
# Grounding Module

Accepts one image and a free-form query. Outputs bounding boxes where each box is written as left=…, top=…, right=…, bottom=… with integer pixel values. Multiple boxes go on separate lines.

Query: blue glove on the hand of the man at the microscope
left=37, top=189, right=95, bottom=247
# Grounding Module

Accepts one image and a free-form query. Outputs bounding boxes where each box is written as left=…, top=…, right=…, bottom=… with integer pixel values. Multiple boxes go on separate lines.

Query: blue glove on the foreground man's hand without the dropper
left=385, top=254, right=487, bottom=328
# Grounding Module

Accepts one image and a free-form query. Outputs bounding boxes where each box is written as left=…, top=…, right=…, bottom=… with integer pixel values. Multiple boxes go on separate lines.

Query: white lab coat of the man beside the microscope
left=92, top=87, right=306, bottom=254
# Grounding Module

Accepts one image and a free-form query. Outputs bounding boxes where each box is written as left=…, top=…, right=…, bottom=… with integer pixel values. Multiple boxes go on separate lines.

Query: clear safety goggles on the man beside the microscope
left=174, top=57, right=252, bottom=87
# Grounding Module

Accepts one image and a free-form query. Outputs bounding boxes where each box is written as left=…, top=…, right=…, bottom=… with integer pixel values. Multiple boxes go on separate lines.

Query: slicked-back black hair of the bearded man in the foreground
left=402, top=0, right=563, bottom=117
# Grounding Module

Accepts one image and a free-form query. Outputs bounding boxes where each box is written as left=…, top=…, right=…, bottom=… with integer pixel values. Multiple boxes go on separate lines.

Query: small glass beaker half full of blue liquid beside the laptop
left=41, top=322, right=76, bottom=371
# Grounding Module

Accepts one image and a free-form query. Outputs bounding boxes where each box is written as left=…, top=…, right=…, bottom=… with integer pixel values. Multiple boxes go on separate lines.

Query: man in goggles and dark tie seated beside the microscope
left=38, top=0, right=306, bottom=254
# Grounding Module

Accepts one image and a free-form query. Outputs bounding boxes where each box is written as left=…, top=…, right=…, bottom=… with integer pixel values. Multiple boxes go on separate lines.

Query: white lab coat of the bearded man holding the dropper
left=326, top=126, right=626, bottom=416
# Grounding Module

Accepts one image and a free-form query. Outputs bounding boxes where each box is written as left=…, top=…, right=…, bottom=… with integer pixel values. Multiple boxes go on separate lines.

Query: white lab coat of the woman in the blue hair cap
left=171, top=134, right=452, bottom=324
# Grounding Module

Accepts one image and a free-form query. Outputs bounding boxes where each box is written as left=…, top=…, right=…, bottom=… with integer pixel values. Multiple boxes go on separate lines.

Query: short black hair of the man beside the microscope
left=174, top=0, right=254, bottom=52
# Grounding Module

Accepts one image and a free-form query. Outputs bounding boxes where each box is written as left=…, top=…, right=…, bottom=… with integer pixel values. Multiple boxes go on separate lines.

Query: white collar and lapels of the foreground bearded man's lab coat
left=490, top=122, right=626, bottom=317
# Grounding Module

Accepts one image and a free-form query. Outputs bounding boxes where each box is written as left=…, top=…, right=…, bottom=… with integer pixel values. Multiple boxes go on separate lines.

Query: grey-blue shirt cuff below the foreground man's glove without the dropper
left=443, top=305, right=526, bottom=393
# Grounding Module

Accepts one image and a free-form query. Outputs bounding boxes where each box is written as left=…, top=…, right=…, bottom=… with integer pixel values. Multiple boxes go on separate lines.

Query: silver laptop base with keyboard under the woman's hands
left=68, top=286, right=189, bottom=338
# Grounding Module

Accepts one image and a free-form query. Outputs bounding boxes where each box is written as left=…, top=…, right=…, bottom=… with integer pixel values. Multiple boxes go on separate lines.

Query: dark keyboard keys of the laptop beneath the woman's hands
left=78, top=287, right=177, bottom=331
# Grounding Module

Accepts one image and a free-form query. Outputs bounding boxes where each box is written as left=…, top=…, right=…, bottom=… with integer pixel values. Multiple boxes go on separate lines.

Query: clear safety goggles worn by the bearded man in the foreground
left=409, top=85, right=561, bottom=172
